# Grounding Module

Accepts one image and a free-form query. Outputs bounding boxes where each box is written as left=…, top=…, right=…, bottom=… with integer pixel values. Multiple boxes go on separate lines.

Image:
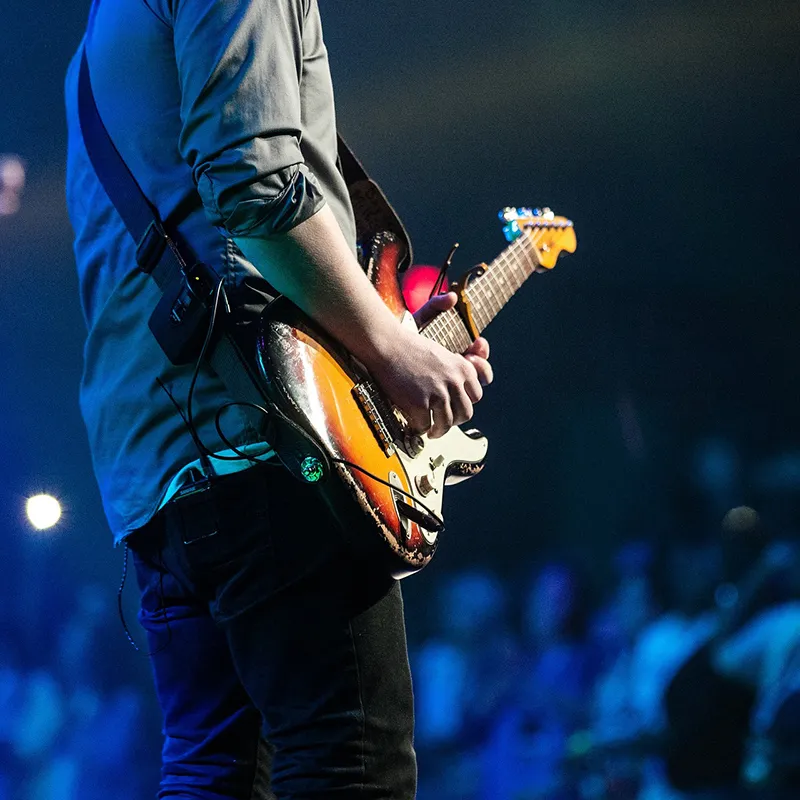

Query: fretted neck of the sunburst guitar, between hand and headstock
left=421, top=223, right=552, bottom=353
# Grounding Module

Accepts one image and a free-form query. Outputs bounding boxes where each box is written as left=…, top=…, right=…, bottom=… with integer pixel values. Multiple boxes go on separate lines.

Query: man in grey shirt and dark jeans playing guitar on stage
left=66, top=0, right=492, bottom=800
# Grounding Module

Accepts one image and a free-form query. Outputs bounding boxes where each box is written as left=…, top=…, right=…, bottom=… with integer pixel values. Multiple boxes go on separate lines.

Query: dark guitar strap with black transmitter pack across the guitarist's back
left=78, top=40, right=411, bottom=472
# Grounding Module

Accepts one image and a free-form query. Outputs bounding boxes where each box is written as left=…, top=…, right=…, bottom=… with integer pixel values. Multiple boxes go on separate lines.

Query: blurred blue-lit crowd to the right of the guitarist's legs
left=415, top=437, right=800, bottom=800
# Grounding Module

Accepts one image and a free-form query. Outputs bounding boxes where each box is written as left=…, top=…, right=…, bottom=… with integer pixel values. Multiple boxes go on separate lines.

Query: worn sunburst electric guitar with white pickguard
left=256, top=208, right=576, bottom=578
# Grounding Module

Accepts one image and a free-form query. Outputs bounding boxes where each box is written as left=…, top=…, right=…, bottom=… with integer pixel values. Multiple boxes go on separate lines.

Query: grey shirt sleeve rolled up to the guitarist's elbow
left=172, top=0, right=324, bottom=237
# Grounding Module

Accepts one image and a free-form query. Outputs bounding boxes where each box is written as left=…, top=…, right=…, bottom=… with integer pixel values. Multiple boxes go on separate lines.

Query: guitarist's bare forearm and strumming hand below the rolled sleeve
left=235, top=206, right=492, bottom=439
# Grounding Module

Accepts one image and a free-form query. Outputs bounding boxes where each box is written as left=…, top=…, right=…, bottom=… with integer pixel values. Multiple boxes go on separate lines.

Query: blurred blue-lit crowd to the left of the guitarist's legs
left=0, top=585, right=153, bottom=800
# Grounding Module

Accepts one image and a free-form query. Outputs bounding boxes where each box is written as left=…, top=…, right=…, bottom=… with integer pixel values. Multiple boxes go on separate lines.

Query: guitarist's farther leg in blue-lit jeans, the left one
left=131, top=519, right=274, bottom=800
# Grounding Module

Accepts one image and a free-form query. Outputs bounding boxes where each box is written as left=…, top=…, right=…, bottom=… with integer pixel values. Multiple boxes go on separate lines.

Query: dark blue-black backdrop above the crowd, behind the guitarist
left=0, top=0, right=800, bottom=792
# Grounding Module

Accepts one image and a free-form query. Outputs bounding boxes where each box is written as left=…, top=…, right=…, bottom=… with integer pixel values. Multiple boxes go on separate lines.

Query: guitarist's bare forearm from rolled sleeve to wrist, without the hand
left=235, top=206, right=401, bottom=364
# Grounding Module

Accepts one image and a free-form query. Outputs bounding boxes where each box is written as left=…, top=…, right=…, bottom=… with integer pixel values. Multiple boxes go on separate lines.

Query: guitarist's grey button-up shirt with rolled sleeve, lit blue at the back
left=66, top=0, right=355, bottom=541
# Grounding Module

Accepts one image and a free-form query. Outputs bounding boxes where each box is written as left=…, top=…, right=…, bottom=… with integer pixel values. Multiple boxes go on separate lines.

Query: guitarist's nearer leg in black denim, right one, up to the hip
left=203, top=470, right=416, bottom=800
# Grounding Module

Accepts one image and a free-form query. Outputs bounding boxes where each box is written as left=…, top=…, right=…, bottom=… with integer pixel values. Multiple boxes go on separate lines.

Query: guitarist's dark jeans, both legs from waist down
left=130, top=466, right=416, bottom=800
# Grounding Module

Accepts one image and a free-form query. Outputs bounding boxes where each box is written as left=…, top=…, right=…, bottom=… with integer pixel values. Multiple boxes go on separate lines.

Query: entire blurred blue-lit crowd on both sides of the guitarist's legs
left=0, top=437, right=800, bottom=800
